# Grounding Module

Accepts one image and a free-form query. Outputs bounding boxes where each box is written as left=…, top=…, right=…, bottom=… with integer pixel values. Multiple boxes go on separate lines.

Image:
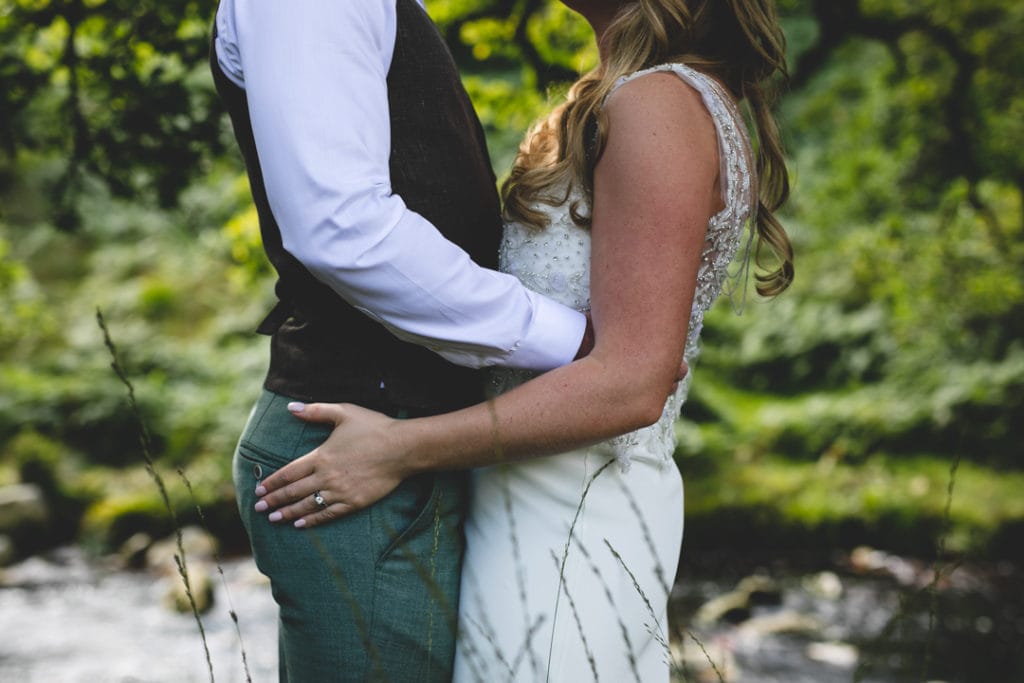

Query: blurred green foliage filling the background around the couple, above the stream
left=0, top=0, right=1024, bottom=555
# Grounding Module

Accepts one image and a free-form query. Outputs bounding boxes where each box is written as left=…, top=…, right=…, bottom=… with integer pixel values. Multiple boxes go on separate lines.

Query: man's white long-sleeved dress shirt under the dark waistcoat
left=215, top=0, right=586, bottom=370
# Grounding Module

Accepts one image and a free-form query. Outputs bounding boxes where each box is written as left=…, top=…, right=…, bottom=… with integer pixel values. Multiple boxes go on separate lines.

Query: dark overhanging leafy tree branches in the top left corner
left=0, top=0, right=223, bottom=227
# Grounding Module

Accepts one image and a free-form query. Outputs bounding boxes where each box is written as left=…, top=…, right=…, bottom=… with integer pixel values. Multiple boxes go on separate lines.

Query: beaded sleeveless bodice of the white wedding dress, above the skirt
left=494, top=63, right=755, bottom=469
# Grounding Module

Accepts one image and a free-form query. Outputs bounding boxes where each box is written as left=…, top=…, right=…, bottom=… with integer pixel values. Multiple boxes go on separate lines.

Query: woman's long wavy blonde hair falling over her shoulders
left=502, top=0, right=794, bottom=296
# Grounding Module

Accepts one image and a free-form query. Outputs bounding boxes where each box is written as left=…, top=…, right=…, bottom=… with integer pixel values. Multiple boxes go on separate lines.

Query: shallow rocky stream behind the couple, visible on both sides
left=0, top=548, right=1024, bottom=683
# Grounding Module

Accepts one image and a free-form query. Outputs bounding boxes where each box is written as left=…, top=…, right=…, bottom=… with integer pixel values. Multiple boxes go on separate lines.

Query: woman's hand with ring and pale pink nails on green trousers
left=256, top=403, right=412, bottom=528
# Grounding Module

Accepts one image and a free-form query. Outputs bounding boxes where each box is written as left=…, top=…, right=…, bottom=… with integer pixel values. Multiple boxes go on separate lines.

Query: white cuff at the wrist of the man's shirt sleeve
left=502, top=296, right=587, bottom=371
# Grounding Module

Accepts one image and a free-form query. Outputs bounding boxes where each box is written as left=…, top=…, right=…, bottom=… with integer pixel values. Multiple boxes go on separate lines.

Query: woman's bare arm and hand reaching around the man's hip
left=258, top=74, right=722, bottom=526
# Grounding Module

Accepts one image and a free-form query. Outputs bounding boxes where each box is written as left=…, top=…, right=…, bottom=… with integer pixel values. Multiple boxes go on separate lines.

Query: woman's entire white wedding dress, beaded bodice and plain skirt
left=455, top=65, right=755, bottom=683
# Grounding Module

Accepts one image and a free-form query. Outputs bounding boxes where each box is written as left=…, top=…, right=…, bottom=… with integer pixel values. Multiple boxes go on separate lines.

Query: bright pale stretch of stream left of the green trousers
left=0, top=548, right=278, bottom=683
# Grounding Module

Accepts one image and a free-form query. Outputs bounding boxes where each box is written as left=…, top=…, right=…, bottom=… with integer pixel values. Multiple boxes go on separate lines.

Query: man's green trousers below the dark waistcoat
left=233, top=391, right=466, bottom=683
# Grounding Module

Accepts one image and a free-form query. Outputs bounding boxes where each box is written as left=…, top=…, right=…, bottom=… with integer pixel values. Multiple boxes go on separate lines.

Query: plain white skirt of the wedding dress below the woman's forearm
left=454, top=445, right=683, bottom=683
